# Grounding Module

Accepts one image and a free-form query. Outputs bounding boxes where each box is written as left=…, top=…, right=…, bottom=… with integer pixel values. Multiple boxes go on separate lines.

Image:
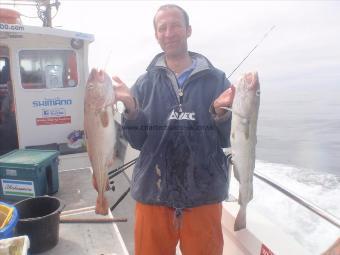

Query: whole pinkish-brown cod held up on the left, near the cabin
left=84, top=69, right=116, bottom=215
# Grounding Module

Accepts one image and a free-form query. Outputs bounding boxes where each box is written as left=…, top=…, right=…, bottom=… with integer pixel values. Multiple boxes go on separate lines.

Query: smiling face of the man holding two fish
left=155, top=8, right=191, bottom=57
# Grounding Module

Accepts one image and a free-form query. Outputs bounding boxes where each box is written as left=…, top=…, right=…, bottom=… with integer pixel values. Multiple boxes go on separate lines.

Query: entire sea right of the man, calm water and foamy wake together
left=251, top=79, right=340, bottom=254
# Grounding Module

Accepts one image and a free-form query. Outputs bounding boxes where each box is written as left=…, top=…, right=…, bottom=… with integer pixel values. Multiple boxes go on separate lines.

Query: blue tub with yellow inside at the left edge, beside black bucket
left=0, top=202, right=19, bottom=239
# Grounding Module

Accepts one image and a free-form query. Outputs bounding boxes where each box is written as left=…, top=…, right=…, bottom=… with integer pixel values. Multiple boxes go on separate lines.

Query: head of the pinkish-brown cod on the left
left=85, top=68, right=115, bottom=110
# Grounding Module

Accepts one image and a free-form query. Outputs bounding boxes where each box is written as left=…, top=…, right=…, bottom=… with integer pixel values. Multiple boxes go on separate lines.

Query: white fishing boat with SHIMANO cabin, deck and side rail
left=0, top=4, right=340, bottom=255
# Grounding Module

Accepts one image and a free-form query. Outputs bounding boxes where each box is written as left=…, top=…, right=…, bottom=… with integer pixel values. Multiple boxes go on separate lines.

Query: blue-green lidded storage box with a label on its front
left=0, top=149, right=59, bottom=201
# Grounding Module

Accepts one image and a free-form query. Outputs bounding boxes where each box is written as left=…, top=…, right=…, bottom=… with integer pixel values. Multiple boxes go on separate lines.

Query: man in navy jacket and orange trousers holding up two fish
left=113, top=5, right=234, bottom=255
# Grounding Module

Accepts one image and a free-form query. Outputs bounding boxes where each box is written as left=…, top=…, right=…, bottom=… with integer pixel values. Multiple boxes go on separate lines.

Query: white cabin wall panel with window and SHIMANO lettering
left=14, top=48, right=84, bottom=148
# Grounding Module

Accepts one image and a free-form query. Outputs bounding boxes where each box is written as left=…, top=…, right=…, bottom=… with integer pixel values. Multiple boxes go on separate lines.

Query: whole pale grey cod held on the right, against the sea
left=230, top=72, right=260, bottom=231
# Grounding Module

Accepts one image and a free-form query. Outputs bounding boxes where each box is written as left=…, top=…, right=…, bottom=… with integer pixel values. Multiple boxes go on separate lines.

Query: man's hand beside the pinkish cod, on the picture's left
left=112, top=76, right=137, bottom=115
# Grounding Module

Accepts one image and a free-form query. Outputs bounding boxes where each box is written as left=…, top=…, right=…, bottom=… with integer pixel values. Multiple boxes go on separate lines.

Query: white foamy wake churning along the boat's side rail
left=254, top=160, right=340, bottom=254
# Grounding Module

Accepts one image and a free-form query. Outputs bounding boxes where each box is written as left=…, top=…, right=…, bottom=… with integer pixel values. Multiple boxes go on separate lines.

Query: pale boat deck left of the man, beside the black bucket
left=37, top=154, right=132, bottom=255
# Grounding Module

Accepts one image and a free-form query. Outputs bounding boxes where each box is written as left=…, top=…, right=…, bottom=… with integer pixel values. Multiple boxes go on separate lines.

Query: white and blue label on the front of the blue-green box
left=1, top=179, right=35, bottom=197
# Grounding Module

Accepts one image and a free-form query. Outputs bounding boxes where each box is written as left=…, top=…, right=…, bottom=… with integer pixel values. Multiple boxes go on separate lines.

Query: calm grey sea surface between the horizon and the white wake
left=256, top=82, right=340, bottom=177
